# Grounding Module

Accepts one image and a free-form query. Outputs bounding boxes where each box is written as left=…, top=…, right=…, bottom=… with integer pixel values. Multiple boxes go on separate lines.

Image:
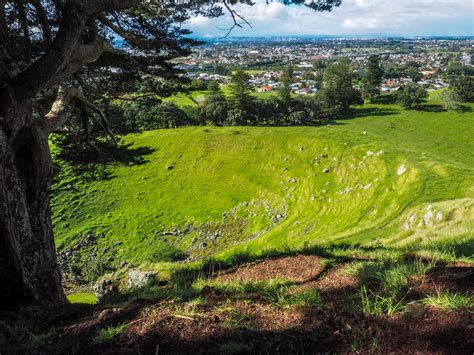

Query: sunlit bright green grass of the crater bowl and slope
left=53, top=98, right=474, bottom=263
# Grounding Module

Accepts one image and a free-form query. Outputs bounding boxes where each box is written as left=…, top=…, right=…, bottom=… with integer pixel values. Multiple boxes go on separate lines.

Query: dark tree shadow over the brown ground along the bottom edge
left=27, top=287, right=473, bottom=354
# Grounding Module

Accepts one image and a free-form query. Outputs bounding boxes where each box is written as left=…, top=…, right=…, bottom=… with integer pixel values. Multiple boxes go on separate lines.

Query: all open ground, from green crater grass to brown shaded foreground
left=5, top=97, right=474, bottom=354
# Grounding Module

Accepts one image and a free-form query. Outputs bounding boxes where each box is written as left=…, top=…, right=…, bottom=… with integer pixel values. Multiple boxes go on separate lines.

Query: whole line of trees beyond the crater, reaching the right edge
left=114, top=55, right=474, bottom=133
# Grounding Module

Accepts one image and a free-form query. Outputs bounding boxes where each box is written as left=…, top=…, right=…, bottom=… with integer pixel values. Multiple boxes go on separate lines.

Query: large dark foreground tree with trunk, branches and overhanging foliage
left=0, top=0, right=341, bottom=308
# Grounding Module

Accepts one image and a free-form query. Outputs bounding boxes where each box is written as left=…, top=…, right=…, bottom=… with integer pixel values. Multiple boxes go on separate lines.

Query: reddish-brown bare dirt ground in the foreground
left=0, top=255, right=474, bottom=354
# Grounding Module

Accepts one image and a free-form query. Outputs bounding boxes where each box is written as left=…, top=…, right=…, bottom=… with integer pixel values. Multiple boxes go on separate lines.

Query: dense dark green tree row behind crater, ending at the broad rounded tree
left=117, top=60, right=363, bottom=131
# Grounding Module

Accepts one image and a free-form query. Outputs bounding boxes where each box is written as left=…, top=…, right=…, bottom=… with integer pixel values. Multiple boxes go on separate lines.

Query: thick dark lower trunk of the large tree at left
left=0, top=87, right=66, bottom=309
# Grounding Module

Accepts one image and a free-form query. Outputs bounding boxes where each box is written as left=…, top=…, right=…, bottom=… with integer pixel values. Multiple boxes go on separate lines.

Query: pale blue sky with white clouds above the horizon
left=186, top=0, right=474, bottom=37
